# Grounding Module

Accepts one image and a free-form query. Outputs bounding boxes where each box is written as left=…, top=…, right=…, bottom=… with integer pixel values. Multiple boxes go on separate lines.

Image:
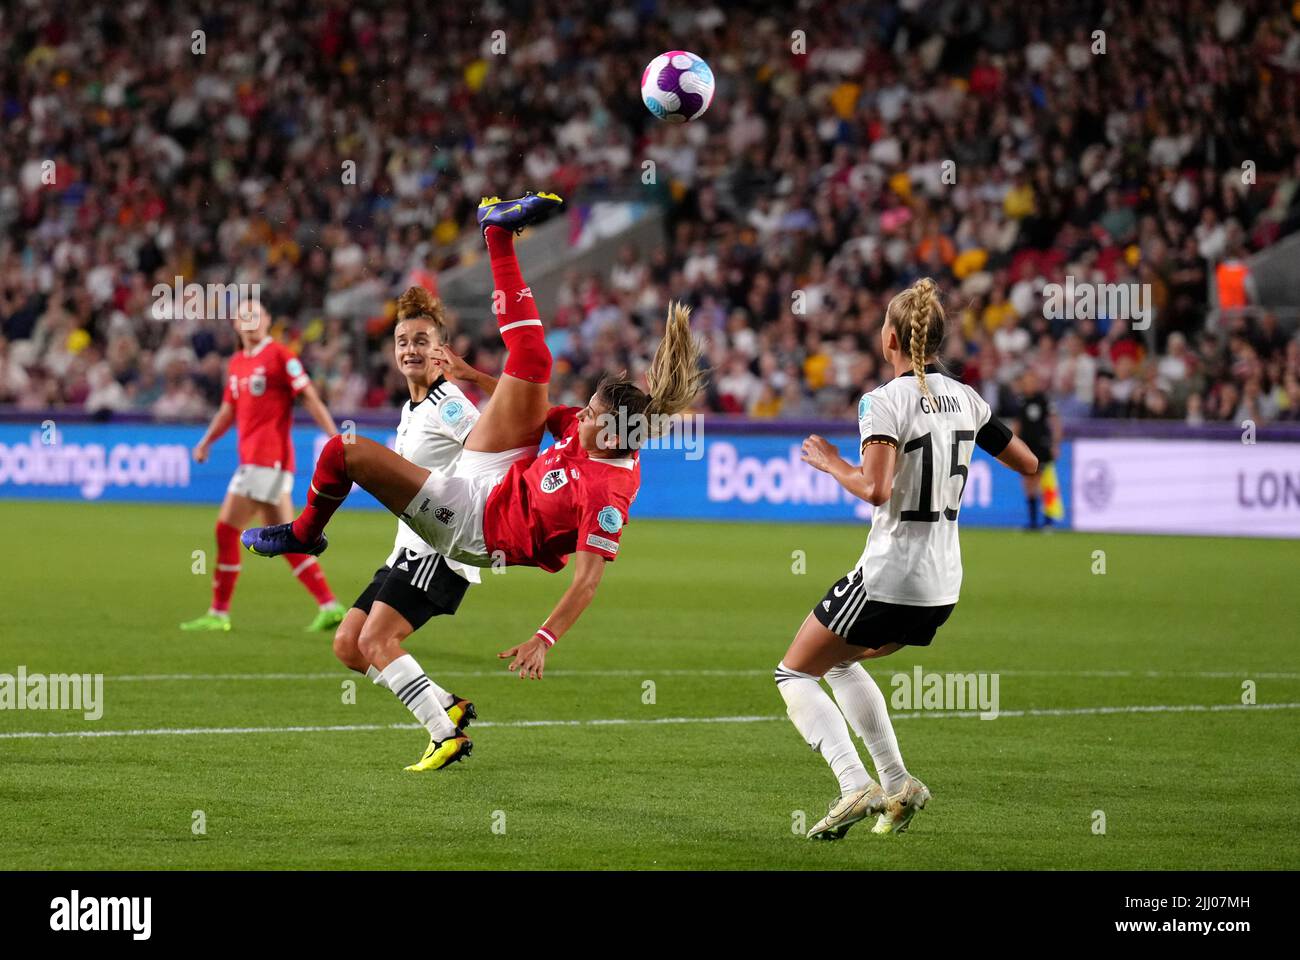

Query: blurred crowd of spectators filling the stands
left=0, top=0, right=1300, bottom=423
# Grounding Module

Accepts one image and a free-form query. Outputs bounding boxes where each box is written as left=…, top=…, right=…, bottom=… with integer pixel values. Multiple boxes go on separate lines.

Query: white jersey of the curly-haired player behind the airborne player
left=386, top=377, right=480, bottom=583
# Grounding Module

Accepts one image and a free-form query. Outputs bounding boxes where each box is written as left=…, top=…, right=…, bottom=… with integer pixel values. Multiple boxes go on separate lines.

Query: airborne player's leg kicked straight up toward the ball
left=465, top=194, right=562, bottom=453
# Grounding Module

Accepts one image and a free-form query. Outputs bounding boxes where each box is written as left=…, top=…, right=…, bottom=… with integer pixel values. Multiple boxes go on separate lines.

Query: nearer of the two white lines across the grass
left=0, top=702, right=1300, bottom=740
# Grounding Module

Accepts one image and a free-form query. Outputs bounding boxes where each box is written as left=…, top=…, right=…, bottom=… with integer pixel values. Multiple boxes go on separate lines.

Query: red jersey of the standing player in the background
left=222, top=337, right=312, bottom=471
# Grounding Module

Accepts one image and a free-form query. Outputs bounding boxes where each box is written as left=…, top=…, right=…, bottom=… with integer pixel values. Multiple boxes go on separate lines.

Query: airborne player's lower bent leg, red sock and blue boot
left=239, top=434, right=429, bottom=557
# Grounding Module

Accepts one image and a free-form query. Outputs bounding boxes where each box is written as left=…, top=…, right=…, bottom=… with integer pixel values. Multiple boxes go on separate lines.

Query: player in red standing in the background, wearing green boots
left=181, top=303, right=343, bottom=631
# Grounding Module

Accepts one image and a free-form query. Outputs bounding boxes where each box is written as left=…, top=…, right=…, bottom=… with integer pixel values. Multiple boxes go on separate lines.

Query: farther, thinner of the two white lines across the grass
left=104, top=667, right=1300, bottom=683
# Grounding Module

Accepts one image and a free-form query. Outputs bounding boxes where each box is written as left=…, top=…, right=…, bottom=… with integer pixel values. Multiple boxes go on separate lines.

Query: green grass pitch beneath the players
left=0, top=501, right=1300, bottom=870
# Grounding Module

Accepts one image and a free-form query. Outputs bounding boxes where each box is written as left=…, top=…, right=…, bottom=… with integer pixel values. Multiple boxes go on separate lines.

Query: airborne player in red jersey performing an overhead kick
left=242, top=194, right=703, bottom=770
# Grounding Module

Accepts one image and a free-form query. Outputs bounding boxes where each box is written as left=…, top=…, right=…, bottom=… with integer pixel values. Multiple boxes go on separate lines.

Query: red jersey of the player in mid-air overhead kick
left=484, top=407, right=641, bottom=574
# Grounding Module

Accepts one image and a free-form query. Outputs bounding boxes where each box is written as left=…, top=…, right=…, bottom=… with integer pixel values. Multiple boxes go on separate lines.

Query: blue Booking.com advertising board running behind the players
left=0, top=423, right=1070, bottom=526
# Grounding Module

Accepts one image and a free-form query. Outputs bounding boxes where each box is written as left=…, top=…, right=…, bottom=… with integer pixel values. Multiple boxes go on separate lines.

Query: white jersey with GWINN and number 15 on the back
left=855, top=367, right=992, bottom=606
